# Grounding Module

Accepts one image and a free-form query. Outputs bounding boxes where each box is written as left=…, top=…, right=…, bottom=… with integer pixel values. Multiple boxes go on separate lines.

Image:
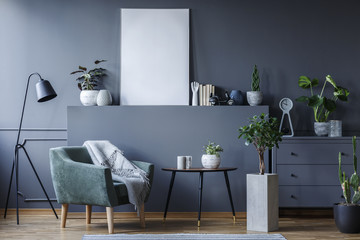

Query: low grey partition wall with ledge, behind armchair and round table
left=68, top=106, right=269, bottom=212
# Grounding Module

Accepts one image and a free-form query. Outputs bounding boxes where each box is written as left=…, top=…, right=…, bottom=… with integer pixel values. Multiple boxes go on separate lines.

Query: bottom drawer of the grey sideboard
left=279, top=186, right=344, bottom=207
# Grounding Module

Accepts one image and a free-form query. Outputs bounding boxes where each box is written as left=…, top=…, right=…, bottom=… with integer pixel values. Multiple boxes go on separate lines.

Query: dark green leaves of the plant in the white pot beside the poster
left=70, top=60, right=106, bottom=91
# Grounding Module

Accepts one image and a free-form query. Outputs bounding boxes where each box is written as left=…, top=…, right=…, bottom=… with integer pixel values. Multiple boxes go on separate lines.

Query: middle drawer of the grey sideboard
left=277, top=165, right=354, bottom=187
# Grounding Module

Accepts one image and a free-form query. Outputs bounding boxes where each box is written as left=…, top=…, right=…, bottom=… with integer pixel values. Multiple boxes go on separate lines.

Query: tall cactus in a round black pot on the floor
left=334, top=136, right=360, bottom=233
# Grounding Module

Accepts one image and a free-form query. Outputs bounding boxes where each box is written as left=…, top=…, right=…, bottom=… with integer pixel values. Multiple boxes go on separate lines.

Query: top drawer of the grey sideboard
left=276, top=143, right=352, bottom=164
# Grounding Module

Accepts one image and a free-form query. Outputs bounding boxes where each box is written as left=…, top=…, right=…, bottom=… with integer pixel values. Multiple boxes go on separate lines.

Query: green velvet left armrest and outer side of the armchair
left=50, top=150, right=117, bottom=207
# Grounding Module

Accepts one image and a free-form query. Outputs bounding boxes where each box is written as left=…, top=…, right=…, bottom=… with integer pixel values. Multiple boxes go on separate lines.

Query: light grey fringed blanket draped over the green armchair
left=84, top=140, right=150, bottom=211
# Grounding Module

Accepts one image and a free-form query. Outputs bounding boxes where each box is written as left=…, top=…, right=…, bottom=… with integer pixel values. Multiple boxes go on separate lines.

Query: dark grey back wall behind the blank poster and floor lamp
left=0, top=0, right=360, bottom=210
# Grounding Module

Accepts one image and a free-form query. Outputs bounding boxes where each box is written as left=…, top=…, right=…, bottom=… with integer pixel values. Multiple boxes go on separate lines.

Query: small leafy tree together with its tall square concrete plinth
left=239, top=114, right=283, bottom=232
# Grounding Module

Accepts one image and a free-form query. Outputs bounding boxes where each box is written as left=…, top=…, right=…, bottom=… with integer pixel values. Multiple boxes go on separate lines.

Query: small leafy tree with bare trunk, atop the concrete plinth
left=238, top=113, right=283, bottom=175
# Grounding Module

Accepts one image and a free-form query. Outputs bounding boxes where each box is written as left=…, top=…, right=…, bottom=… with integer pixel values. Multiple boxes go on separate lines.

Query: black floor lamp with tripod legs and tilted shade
left=4, top=73, right=58, bottom=224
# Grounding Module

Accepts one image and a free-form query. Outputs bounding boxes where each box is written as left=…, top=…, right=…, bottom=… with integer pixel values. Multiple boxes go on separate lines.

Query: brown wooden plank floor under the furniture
left=0, top=212, right=360, bottom=240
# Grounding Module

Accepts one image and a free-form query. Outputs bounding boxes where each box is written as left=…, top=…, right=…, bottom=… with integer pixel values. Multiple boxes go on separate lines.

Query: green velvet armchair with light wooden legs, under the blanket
left=50, top=146, right=154, bottom=233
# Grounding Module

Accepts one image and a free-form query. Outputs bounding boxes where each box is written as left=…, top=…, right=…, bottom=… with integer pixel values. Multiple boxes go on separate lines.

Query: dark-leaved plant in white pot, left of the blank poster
left=70, top=60, right=106, bottom=106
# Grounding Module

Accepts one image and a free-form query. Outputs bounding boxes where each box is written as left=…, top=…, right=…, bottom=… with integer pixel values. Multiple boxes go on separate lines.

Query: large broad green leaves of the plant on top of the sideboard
left=296, top=75, right=349, bottom=122
